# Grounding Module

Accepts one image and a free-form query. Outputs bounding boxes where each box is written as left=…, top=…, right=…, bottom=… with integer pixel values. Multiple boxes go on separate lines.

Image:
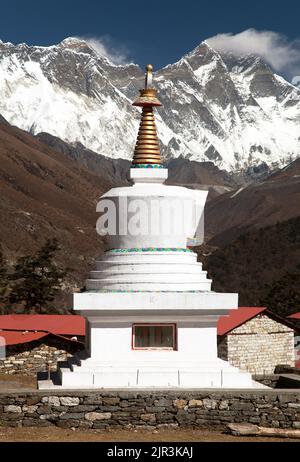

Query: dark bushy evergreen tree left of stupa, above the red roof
left=9, top=239, right=67, bottom=313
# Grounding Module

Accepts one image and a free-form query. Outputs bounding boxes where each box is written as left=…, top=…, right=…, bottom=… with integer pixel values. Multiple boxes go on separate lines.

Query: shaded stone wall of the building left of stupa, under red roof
left=0, top=335, right=84, bottom=376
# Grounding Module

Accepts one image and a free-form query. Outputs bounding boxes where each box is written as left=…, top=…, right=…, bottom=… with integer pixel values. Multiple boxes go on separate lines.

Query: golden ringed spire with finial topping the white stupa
left=132, top=64, right=161, bottom=165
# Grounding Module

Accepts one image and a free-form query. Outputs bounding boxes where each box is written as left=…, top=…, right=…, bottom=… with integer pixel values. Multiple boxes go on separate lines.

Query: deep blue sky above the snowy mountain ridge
left=0, top=0, right=300, bottom=78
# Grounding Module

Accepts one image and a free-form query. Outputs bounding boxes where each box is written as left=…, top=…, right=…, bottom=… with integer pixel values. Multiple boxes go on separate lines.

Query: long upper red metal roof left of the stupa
left=0, top=314, right=85, bottom=335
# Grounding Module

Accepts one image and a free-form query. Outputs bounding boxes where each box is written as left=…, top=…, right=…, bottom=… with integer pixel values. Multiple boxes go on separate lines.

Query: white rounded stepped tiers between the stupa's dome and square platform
left=86, top=249, right=211, bottom=291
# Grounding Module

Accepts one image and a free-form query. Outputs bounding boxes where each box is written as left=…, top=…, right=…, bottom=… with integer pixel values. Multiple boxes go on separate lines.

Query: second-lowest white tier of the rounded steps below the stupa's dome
left=90, top=265, right=207, bottom=279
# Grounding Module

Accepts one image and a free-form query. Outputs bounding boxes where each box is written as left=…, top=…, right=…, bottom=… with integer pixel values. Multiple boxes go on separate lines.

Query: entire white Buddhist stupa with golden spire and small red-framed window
left=39, top=65, right=262, bottom=388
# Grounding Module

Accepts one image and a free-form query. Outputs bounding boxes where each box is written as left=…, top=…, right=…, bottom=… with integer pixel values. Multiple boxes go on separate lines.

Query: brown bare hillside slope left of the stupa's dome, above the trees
left=0, top=118, right=110, bottom=306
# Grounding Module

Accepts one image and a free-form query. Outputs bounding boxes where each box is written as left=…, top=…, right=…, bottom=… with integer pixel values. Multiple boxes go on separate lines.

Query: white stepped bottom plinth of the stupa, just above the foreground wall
left=39, top=355, right=267, bottom=389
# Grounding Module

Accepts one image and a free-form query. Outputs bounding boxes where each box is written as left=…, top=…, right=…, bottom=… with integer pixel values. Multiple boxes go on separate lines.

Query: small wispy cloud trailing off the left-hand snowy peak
left=78, top=36, right=130, bottom=65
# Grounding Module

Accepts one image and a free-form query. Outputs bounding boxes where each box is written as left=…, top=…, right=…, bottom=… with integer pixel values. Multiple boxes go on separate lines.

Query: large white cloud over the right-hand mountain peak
left=206, top=29, right=300, bottom=78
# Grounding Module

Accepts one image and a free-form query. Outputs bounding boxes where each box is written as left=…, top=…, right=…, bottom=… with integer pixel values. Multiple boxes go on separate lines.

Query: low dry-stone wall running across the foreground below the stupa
left=0, top=390, right=300, bottom=429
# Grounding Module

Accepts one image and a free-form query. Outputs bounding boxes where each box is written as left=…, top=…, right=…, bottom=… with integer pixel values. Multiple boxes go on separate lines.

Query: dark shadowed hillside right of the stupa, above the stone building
left=199, top=216, right=300, bottom=315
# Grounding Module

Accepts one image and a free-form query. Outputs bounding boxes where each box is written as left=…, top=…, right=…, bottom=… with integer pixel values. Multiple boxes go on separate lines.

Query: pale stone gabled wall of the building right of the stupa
left=218, top=314, right=295, bottom=374
